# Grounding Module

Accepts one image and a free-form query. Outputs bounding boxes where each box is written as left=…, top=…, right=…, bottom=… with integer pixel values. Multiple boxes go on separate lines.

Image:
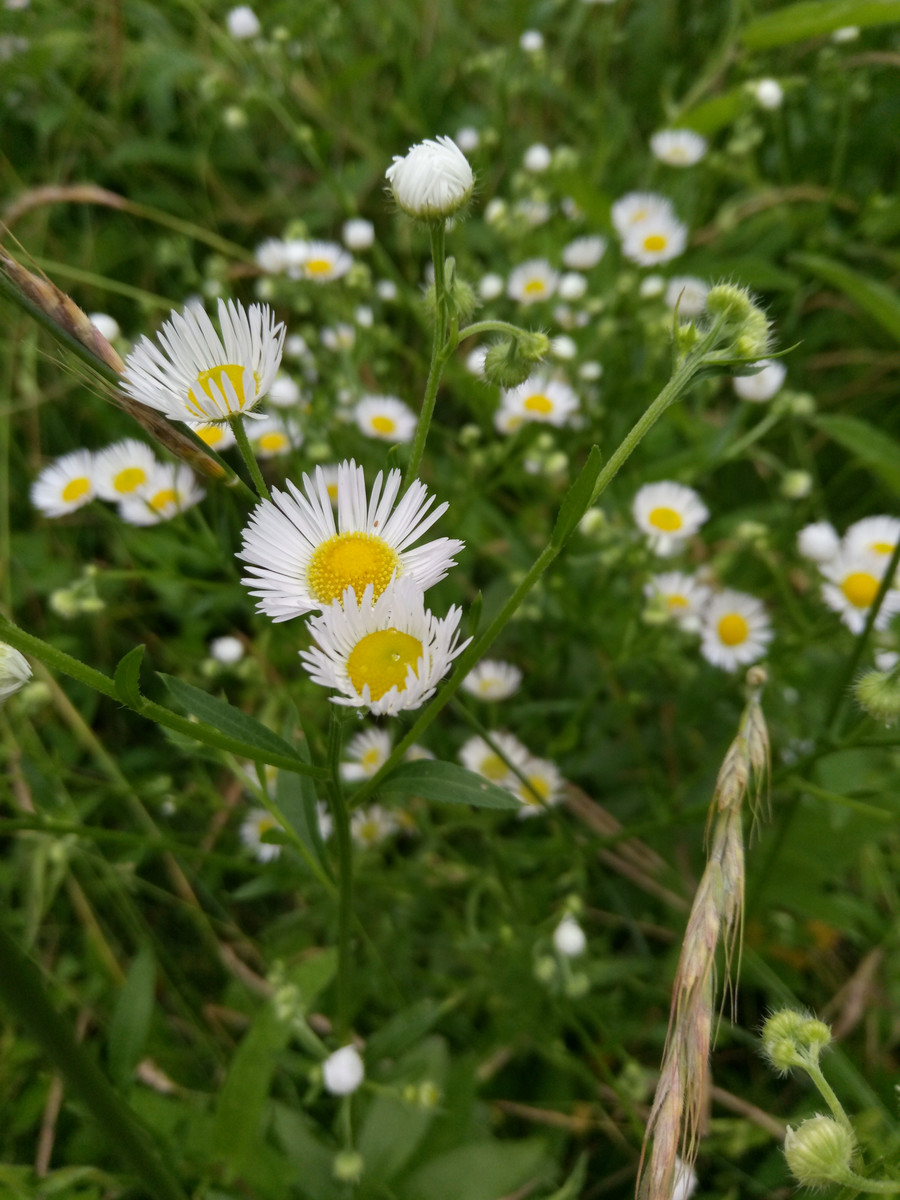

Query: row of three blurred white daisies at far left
left=31, top=438, right=204, bottom=526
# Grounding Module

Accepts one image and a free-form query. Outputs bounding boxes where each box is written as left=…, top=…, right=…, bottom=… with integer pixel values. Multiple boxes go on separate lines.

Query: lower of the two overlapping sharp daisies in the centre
left=300, top=577, right=472, bottom=716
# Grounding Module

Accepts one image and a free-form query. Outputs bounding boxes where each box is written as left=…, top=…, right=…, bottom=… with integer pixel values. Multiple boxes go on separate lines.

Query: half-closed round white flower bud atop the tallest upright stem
left=385, top=137, right=475, bottom=221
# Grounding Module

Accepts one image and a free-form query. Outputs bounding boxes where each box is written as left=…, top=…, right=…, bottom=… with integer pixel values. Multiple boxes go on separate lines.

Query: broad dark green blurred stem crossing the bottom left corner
left=0, top=929, right=187, bottom=1200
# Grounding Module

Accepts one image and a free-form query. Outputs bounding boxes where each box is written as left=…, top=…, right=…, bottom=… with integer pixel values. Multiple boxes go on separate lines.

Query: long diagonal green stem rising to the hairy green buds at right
left=349, top=343, right=719, bottom=808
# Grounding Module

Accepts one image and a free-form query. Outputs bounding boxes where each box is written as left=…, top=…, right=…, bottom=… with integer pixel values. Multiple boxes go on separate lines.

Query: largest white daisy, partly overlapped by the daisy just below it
left=238, top=460, right=463, bottom=622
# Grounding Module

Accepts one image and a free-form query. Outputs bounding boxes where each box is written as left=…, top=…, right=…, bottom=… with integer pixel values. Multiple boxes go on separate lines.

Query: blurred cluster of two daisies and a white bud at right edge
left=797, top=516, right=900, bottom=634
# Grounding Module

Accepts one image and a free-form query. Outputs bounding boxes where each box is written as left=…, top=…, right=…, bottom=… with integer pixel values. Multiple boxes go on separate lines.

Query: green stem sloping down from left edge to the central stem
left=0, top=614, right=328, bottom=779
